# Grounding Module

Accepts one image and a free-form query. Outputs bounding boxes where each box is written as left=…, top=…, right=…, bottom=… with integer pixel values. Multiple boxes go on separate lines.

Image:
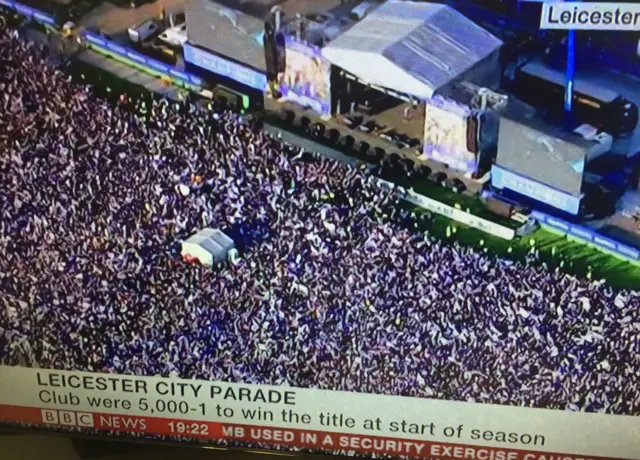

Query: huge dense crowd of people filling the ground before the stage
left=0, top=22, right=640, bottom=415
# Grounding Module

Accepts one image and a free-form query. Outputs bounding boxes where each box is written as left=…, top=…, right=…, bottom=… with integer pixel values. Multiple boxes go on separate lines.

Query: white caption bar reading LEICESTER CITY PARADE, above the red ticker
left=0, top=366, right=640, bottom=460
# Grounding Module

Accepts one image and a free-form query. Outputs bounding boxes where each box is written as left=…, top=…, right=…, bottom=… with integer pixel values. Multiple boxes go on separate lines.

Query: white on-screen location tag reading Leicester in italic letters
left=540, top=2, right=640, bottom=31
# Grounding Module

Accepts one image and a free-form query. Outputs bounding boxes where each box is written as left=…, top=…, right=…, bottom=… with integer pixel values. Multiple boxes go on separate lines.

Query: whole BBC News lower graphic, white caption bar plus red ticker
left=0, top=366, right=640, bottom=460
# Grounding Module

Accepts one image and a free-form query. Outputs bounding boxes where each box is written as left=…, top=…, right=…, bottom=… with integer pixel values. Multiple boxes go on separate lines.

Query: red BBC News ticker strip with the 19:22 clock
left=0, top=405, right=624, bottom=460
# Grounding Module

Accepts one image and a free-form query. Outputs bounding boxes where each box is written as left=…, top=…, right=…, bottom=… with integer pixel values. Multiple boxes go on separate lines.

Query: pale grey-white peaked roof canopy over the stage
left=322, top=0, right=502, bottom=98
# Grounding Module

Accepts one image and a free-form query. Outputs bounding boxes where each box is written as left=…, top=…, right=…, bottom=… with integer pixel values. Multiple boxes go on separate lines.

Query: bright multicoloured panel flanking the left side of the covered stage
left=278, top=36, right=331, bottom=115
